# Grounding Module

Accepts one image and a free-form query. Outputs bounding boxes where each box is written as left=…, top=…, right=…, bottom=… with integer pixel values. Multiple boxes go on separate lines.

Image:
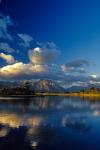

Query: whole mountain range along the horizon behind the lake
left=0, top=79, right=100, bottom=93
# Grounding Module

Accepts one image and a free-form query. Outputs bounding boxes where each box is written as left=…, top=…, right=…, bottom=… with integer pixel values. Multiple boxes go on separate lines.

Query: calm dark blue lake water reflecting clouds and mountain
left=0, top=97, right=100, bottom=150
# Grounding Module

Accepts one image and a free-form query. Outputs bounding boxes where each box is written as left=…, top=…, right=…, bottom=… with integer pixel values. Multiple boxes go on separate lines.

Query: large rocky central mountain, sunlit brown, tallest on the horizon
left=33, top=80, right=65, bottom=93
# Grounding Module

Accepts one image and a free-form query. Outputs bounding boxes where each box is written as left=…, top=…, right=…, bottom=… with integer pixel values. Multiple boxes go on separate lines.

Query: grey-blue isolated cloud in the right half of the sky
left=61, top=59, right=89, bottom=73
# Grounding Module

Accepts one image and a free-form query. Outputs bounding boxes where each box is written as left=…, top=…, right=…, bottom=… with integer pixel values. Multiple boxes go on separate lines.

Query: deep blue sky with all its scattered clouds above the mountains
left=0, top=0, right=100, bottom=85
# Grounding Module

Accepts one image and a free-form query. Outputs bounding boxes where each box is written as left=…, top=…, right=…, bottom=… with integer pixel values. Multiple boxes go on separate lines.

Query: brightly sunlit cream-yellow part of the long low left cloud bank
left=0, top=62, right=48, bottom=78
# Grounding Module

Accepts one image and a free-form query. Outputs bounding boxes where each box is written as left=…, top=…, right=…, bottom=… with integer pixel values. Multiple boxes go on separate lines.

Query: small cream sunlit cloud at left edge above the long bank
left=0, top=53, right=15, bottom=64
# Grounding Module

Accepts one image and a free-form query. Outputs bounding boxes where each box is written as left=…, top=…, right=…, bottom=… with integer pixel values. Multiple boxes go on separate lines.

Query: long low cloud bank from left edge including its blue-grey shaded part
left=0, top=62, right=60, bottom=79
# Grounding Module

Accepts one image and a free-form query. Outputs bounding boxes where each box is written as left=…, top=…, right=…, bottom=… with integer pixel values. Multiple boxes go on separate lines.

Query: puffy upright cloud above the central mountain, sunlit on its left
left=29, top=44, right=60, bottom=65
